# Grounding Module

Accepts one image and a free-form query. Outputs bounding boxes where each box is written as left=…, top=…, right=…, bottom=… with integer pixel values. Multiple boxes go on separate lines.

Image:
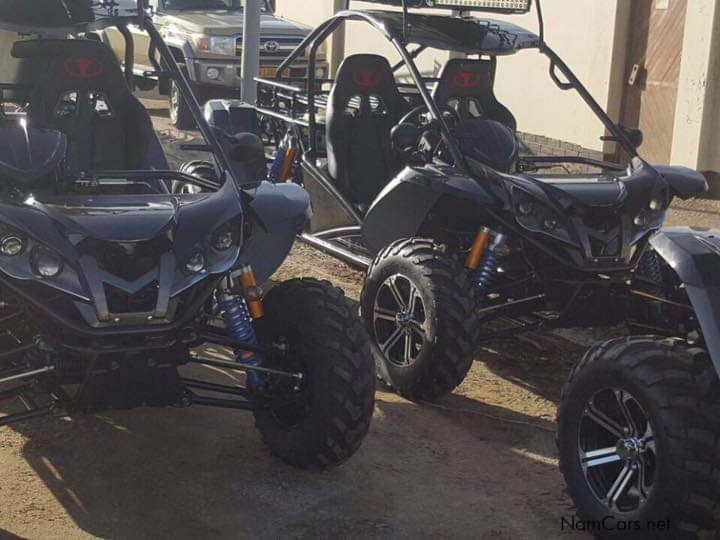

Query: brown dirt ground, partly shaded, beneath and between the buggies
left=0, top=95, right=716, bottom=539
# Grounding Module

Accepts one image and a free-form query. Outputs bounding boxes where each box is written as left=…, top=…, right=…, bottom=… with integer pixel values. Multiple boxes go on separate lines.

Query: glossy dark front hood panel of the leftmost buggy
left=0, top=182, right=242, bottom=306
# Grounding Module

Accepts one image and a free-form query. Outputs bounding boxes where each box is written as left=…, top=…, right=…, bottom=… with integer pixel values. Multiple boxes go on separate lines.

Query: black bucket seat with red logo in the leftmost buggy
left=12, top=39, right=167, bottom=173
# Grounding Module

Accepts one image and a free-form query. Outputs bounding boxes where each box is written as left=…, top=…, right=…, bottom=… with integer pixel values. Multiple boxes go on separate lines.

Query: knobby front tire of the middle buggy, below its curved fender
left=360, top=238, right=478, bottom=400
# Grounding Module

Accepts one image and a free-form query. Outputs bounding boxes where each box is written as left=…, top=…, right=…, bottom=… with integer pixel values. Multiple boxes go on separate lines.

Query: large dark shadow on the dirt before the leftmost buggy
left=0, top=372, right=584, bottom=538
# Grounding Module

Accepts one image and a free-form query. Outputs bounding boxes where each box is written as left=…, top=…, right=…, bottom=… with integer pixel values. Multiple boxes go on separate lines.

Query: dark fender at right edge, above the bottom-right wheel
left=650, top=227, right=720, bottom=375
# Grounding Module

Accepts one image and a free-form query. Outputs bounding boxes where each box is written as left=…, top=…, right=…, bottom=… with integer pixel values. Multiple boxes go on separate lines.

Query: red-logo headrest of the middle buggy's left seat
left=333, top=54, right=402, bottom=108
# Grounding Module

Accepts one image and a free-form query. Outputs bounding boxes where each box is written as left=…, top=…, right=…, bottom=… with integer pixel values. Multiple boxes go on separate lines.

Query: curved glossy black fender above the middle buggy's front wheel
left=362, top=165, right=497, bottom=253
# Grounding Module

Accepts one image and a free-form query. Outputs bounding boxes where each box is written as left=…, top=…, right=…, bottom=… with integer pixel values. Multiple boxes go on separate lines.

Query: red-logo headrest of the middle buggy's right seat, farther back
left=433, top=58, right=495, bottom=103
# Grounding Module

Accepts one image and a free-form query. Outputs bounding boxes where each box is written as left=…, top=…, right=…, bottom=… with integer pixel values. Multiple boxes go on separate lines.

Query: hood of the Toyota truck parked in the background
left=166, top=10, right=312, bottom=37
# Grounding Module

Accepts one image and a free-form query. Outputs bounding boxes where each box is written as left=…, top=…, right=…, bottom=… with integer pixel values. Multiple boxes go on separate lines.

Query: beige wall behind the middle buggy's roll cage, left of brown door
left=278, top=0, right=630, bottom=150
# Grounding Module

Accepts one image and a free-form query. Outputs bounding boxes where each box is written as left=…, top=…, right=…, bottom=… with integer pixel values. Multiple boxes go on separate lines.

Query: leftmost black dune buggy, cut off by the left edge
left=0, top=0, right=374, bottom=468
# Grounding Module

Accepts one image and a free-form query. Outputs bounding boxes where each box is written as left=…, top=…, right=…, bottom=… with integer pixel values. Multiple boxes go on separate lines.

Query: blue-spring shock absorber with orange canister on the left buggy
left=219, top=266, right=263, bottom=390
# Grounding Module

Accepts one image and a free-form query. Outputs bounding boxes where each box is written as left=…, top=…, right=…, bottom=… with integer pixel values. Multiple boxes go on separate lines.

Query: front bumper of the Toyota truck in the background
left=188, top=58, right=328, bottom=88
